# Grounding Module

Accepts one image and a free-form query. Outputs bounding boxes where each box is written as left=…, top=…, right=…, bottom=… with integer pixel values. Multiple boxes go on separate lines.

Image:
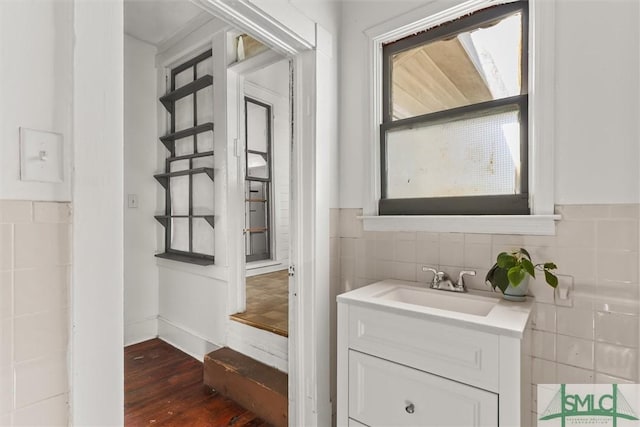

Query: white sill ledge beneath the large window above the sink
left=358, top=215, right=561, bottom=236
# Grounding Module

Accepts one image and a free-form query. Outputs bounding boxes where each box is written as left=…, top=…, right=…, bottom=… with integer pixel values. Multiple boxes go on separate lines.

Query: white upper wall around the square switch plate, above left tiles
left=0, top=1, right=73, bottom=201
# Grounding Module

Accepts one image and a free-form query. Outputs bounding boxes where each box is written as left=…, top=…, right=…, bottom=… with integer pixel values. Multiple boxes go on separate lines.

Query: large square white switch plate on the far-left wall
left=20, top=128, right=64, bottom=183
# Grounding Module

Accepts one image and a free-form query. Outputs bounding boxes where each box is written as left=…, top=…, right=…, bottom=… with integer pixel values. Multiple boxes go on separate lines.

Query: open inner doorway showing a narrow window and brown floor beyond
left=231, top=51, right=292, bottom=337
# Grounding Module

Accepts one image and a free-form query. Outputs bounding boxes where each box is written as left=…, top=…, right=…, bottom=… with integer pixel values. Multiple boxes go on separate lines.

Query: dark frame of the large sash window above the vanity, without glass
left=378, top=0, right=531, bottom=215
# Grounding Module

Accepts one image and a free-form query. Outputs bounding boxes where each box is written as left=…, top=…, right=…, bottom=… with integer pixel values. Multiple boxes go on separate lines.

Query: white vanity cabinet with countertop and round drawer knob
left=337, top=280, right=531, bottom=427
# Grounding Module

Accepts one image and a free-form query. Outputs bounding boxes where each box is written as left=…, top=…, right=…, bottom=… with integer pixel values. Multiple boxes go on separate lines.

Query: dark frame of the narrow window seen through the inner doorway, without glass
left=244, top=96, right=273, bottom=262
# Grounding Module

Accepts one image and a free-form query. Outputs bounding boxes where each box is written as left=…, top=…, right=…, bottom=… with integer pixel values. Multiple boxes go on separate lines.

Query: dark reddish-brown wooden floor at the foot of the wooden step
left=124, top=339, right=269, bottom=427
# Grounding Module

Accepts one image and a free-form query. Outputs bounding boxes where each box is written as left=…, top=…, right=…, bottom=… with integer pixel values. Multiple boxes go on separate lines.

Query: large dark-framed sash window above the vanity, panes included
left=379, top=1, right=530, bottom=215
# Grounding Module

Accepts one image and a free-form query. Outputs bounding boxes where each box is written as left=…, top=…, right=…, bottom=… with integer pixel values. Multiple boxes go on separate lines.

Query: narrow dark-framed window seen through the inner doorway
left=244, top=97, right=271, bottom=262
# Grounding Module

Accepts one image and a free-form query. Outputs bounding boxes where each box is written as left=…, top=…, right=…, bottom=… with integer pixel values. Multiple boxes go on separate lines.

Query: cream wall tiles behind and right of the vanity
left=331, top=205, right=639, bottom=424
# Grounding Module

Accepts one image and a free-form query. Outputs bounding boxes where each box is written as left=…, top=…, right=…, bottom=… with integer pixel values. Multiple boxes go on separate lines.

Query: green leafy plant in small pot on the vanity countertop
left=485, top=248, right=558, bottom=301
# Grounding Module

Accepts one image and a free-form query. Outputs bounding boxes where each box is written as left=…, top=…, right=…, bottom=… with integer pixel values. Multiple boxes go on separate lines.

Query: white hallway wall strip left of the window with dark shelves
left=124, top=34, right=161, bottom=345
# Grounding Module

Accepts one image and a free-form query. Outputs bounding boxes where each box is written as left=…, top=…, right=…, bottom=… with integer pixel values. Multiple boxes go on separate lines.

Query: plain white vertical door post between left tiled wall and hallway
left=72, top=0, right=124, bottom=426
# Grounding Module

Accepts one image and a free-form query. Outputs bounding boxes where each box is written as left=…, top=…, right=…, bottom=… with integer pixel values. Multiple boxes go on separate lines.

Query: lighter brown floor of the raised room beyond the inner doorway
left=231, top=270, right=289, bottom=337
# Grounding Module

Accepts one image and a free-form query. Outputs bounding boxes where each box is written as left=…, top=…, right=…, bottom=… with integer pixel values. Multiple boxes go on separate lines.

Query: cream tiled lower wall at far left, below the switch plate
left=0, top=200, right=71, bottom=426
